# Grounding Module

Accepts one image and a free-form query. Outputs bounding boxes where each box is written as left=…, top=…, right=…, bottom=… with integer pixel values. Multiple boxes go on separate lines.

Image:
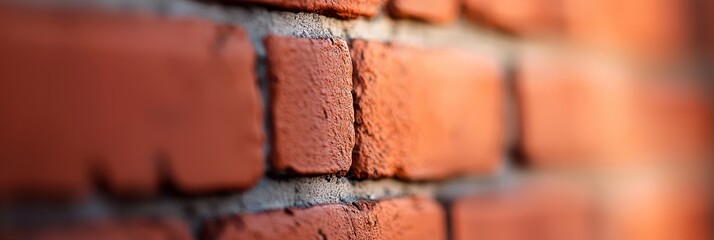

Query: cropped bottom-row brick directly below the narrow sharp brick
left=204, top=197, right=446, bottom=239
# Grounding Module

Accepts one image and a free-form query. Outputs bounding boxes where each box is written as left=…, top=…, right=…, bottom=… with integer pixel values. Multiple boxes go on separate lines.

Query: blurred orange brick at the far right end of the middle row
left=636, top=77, right=714, bottom=164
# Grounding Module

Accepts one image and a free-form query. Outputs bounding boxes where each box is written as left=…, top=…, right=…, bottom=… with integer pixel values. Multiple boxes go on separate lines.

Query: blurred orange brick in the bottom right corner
left=600, top=173, right=713, bottom=240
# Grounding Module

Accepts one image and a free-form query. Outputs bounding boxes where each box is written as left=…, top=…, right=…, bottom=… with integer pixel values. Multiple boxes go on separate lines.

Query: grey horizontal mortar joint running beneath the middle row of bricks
left=0, top=164, right=517, bottom=228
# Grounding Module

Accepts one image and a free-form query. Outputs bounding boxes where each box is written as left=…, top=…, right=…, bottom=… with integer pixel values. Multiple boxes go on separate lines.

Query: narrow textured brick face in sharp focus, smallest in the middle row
left=265, top=36, right=355, bottom=174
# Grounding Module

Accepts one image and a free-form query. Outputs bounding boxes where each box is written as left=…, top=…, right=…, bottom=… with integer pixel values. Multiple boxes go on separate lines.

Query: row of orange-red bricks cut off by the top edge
left=211, top=0, right=696, bottom=59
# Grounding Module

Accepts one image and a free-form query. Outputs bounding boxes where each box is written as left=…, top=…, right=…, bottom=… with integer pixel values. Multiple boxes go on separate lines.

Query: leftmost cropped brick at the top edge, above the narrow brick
left=227, top=0, right=386, bottom=19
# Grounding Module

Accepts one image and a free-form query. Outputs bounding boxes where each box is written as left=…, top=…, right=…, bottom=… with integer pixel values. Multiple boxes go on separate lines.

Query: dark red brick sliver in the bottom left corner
left=0, top=219, right=192, bottom=240
